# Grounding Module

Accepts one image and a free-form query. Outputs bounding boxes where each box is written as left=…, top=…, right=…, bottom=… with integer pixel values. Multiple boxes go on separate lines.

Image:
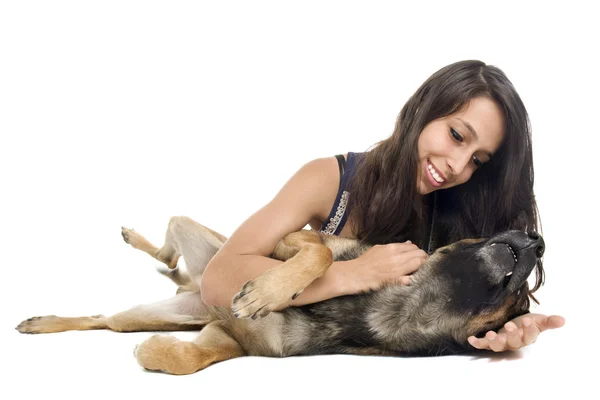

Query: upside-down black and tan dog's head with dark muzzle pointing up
left=404, top=231, right=544, bottom=352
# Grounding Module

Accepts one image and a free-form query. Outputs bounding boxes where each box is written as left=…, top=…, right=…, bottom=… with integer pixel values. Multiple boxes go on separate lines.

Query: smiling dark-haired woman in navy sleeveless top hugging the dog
left=202, top=61, right=564, bottom=351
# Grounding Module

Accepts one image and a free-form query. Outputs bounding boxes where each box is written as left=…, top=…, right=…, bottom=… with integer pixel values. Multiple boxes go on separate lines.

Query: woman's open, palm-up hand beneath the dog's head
left=467, top=314, right=565, bottom=352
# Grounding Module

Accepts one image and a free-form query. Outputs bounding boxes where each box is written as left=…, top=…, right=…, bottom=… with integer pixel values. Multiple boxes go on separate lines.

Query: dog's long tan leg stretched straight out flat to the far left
left=16, top=292, right=210, bottom=333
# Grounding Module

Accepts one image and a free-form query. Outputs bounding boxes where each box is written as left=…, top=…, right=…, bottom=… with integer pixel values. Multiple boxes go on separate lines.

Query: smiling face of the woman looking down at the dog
left=417, top=97, right=504, bottom=195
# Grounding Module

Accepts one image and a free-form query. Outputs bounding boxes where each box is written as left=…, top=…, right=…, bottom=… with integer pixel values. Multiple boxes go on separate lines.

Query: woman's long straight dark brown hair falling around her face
left=349, top=60, right=543, bottom=290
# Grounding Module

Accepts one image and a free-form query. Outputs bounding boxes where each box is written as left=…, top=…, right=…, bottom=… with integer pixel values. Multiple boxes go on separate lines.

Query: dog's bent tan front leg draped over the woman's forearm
left=232, top=230, right=333, bottom=319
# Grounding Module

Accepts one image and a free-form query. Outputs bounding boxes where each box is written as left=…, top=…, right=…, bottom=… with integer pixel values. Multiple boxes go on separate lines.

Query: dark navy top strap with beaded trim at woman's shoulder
left=319, top=152, right=363, bottom=235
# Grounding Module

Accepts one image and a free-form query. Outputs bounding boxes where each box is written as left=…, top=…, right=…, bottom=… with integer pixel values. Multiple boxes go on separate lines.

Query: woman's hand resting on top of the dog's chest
left=347, top=241, right=427, bottom=293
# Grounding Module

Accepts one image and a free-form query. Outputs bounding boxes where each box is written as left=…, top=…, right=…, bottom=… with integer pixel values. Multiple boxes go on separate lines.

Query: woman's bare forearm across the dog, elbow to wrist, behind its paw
left=201, top=254, right=351, bottom=310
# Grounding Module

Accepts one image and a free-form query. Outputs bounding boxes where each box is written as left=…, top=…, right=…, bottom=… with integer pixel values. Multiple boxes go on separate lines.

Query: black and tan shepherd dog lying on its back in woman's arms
left=16, top=217, right=545, bottom=375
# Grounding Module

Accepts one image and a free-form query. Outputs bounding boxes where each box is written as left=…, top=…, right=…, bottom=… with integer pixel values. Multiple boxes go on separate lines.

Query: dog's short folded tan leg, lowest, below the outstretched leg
left=134, top=321, right=246, bottom=375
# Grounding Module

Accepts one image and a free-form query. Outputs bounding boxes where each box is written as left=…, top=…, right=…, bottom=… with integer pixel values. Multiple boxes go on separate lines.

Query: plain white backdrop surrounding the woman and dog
left=0, top=1, right=600, bottom=398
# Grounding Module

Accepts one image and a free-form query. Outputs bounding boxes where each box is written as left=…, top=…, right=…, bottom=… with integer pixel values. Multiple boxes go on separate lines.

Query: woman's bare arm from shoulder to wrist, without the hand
left=201, top=157, right=352, bottom=307
